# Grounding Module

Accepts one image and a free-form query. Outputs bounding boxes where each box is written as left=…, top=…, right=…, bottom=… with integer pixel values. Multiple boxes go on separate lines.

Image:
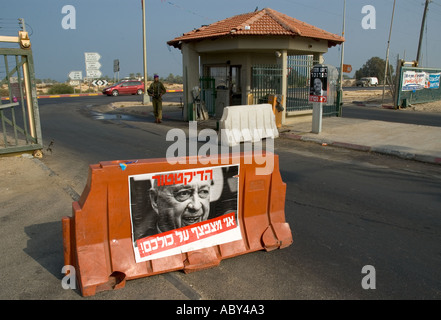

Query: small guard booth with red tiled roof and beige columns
left=167, top=8, right=344, bottom=123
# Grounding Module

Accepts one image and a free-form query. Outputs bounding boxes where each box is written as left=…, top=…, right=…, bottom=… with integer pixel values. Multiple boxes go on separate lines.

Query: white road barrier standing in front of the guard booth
left=219, top=103, right=279, bottom=147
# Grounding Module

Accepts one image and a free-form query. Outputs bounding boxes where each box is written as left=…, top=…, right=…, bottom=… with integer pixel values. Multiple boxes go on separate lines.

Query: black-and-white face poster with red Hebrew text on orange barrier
left=129, top=165, right=242, bottom=262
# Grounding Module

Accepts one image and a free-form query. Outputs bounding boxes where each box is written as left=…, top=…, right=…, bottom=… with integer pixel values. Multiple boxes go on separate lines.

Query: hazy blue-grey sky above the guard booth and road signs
left=0, top=0, right=441, bottom=82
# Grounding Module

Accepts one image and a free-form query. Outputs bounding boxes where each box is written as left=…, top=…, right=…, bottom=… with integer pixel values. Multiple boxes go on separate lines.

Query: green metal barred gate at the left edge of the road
left=0, top=48, right=43, bottom=154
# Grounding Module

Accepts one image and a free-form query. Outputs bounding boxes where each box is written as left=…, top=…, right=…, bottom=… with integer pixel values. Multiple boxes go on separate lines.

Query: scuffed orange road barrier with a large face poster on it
left=62, top=153, right=292, bottom=296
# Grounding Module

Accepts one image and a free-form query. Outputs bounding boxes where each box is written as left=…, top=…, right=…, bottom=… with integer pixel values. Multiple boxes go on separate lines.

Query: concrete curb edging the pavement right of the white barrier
left=279, top=132, right=441, bottom=165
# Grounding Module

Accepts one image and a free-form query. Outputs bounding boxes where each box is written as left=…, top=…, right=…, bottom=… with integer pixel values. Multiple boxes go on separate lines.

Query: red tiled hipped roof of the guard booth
left=167, top=8, right=344, bottom=48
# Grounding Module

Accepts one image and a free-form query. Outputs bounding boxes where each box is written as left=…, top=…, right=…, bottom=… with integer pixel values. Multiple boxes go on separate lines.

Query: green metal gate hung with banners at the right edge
left=395, top=66, right=441, bottom=106
